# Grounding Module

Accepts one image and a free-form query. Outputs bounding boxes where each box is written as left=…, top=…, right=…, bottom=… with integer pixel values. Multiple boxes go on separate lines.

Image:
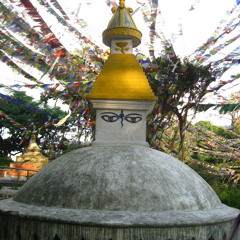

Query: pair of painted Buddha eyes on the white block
left=102, top=112, right=142, bottom=125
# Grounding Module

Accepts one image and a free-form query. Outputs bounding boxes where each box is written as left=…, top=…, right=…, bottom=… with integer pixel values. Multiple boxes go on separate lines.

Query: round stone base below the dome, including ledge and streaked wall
left=0, top=199, right=240, bottom=240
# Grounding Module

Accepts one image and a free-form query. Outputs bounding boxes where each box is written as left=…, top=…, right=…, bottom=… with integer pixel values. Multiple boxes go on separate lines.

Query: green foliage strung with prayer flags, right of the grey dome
left=188, top=121, right=240, bottom=204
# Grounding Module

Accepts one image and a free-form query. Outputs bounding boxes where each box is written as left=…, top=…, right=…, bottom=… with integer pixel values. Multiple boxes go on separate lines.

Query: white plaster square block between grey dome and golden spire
left=91, top=99, right=154, bottom=146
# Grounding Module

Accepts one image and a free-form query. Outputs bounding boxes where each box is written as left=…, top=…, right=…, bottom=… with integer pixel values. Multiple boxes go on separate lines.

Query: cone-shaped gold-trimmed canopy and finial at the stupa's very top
left=102, top=0, right=142, bottom=47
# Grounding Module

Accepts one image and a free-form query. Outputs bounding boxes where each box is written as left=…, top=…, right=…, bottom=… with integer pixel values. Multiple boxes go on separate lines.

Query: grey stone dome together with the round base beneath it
left=0, top=145, right=240, bottom=240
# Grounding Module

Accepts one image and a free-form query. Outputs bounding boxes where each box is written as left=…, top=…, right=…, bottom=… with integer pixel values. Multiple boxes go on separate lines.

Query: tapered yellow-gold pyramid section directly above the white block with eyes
left=87, top=54, right=157, bottom=101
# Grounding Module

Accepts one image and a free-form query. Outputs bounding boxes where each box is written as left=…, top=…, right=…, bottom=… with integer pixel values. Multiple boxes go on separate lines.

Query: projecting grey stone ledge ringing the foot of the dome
left=0, top=199, right=240, bottom=228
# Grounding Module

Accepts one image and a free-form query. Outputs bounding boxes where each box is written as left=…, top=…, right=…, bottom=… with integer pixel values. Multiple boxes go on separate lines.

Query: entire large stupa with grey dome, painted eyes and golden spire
left=0, top=0, right=240, bottom=240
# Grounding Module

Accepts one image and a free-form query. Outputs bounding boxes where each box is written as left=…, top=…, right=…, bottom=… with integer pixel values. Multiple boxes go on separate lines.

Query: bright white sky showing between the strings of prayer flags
left=0, top=0, right=240, bottom=125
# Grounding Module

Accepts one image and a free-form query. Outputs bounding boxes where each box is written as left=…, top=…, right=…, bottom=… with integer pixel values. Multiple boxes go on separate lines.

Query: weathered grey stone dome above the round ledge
left=14, top=146, right=220, bottom=212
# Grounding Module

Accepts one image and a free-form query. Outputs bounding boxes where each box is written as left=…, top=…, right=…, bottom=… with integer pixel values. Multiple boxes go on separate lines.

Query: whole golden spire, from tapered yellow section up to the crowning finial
left=87, top=0, right=157, bottom=101
